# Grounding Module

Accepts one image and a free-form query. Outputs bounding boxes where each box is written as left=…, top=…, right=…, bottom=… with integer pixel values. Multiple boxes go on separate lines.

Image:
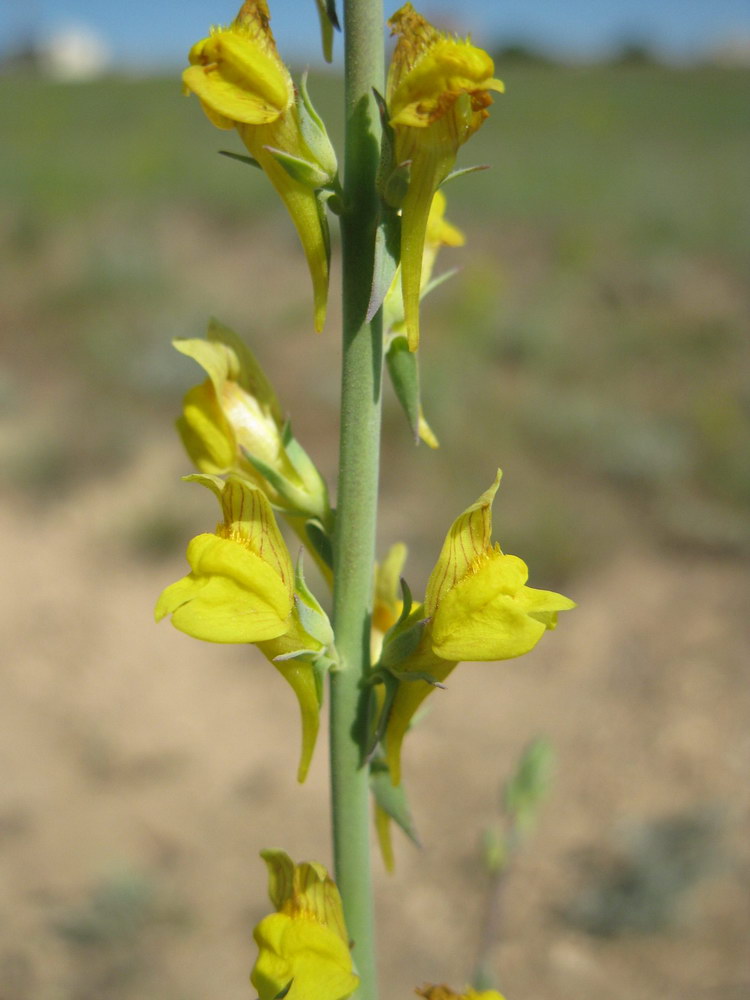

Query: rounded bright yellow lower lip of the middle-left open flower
left=155, top=534, right=292, bottom=642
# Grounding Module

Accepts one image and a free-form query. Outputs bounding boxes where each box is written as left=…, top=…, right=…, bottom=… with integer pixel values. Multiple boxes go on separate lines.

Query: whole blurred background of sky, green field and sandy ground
left=0, top=0, right=750, bottom=1000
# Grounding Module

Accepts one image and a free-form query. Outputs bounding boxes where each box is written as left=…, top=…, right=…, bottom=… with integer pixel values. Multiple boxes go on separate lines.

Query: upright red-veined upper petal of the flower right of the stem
left=425, top=469, right=502, bottom=617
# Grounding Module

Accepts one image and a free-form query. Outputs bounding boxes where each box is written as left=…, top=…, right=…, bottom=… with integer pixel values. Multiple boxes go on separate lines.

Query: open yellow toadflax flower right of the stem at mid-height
left=381, top=471, right=575, bottom=785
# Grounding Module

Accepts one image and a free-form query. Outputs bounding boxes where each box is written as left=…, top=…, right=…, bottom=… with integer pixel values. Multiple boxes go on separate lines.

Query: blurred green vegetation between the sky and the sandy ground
left=0, top=68, right=750, bottom=585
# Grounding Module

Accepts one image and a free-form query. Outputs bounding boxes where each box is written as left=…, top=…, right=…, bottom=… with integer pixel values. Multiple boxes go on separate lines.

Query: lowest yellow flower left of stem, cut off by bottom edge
left=250, top=851, right=359, bottom=1000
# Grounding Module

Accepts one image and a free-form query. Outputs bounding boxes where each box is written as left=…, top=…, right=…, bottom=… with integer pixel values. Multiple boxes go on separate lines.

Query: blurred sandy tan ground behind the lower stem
left=0, top=437, right=750, bottom=1000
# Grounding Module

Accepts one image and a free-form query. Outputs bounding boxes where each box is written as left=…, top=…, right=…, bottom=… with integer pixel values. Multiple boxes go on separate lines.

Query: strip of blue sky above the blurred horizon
left=0, top=0, right=750, bottom=68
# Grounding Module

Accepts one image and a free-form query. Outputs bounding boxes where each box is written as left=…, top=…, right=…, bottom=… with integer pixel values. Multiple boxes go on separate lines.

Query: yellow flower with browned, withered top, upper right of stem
left=386, top=3, right=504, bottom=351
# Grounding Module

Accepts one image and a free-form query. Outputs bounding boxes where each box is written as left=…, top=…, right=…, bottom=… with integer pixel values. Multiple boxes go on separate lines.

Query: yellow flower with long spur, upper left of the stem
left=182, top=0, right=336, bottom=330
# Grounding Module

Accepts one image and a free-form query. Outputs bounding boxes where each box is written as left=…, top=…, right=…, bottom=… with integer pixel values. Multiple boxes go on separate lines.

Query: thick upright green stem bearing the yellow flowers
left=330, top=0, right=384, bottom=1000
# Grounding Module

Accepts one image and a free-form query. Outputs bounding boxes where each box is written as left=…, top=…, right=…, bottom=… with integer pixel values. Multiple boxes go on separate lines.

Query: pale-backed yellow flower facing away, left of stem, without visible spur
left=173, top=320, right=330, bottom=524
